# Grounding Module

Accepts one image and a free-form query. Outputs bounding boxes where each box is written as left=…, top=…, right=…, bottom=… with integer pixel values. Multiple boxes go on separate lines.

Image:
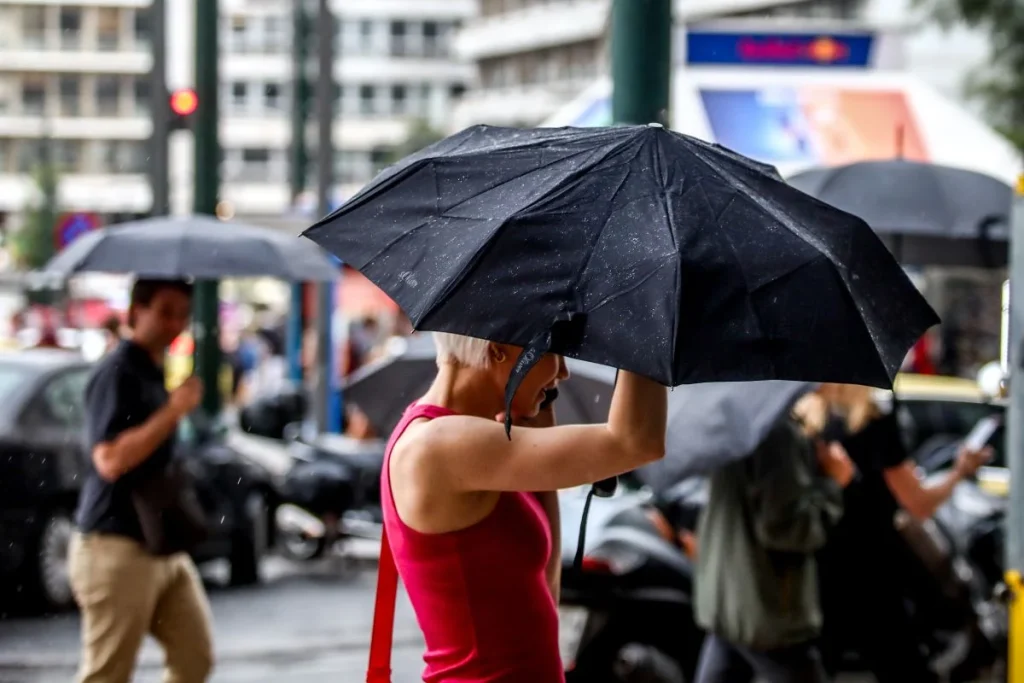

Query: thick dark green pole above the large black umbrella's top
left=611, top=0, right=672, bottom=125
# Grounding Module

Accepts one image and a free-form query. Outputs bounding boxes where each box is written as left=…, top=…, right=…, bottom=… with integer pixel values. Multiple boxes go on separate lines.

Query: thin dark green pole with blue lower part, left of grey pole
left=287, top=0, right=312, bottom=387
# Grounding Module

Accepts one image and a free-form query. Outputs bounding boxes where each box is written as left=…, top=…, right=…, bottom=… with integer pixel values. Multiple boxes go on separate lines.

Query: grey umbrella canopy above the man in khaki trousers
left=44, top=215, right=338, bottom=282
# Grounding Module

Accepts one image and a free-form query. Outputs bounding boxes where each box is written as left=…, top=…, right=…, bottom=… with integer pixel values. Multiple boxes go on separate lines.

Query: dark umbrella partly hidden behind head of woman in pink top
left=344, top=335, right=615, bottom=435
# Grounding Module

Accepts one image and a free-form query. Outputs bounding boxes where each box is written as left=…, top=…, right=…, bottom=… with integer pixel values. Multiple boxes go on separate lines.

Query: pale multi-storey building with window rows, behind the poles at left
left=0, top=0, right=475, bottom=232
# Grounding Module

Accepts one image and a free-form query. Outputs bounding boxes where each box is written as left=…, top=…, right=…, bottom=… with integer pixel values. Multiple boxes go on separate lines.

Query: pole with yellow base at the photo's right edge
left=1006, top=178, right=1024, bottom=683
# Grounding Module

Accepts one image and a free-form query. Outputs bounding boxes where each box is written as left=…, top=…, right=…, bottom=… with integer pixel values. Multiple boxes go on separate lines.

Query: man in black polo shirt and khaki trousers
left=70, top=280, right=213, bottom=683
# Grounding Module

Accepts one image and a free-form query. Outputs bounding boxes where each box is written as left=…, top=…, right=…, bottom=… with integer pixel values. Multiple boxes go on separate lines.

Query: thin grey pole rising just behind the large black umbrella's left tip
left=316, top=0, right=342, bottom=432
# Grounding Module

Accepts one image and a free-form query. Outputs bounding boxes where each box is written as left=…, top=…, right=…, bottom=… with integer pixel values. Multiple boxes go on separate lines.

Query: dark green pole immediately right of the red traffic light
left=193, top=0, right=220, bottom=417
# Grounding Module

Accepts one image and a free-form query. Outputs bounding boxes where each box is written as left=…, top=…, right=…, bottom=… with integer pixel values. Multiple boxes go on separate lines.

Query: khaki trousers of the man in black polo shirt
left=70, top=533, right=213, bottom=683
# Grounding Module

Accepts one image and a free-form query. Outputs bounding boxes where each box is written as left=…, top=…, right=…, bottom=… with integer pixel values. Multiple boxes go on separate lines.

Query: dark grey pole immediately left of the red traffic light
left=148, top=0, right=171, bottom=216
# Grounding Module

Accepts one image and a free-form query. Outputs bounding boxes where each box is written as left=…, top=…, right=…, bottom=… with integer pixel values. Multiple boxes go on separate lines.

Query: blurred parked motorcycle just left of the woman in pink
left=239, top=392, right=384, bottom=561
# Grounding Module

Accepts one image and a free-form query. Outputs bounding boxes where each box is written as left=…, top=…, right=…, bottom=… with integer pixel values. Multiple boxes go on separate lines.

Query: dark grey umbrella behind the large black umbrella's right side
left=790, top=159, right=1014, bottom=266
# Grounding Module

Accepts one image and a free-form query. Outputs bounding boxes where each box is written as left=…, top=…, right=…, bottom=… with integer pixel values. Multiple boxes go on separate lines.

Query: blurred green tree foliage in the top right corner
left=915, top=0, right=1024, bottom=153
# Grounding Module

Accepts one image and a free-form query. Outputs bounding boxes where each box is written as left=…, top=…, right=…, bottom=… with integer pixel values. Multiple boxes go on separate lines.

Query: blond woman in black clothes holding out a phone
left=819, top=384, right=992, bottom=683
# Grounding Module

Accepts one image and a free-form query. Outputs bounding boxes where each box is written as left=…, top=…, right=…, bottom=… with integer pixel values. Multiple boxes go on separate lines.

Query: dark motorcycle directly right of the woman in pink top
left=560, top=481, right=703, bottom=683
